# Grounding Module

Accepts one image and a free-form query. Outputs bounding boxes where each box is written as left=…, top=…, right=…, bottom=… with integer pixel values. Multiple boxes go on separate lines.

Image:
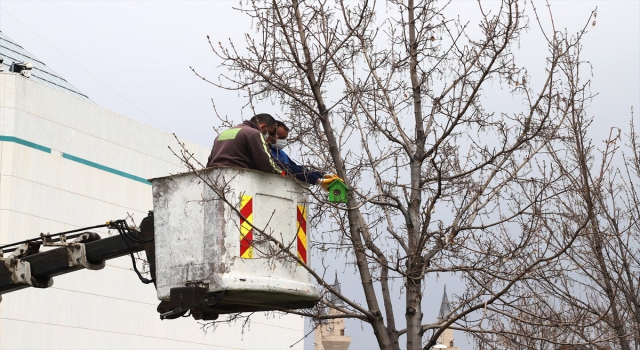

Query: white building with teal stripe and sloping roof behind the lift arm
left=0, top=32, right=304, bottom=349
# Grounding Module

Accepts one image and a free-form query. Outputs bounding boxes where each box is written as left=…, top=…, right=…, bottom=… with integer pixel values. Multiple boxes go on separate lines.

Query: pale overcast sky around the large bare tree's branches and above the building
left=0, top=0, right=640, bottom=350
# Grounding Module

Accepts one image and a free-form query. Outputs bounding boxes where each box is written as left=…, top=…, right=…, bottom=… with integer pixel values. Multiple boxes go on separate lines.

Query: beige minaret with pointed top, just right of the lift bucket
left=313, top=271, right=351, bottom=350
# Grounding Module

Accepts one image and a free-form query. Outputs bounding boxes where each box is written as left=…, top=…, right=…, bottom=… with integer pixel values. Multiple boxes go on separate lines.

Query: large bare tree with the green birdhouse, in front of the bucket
left=183, top=0, right=597, bottom=350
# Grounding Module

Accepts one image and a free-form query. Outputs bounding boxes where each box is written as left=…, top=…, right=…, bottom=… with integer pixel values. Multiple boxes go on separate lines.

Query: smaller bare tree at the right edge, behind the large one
left=450, top=47, right=640, bottom=349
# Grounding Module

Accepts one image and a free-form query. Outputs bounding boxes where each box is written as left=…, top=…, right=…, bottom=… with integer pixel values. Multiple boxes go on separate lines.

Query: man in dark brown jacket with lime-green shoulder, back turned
left=207, top=113, right=282, bottom=174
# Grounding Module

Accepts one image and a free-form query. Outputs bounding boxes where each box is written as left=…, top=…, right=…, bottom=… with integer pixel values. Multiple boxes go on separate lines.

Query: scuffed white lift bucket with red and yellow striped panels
left=150, top=168, right=319, bottom=319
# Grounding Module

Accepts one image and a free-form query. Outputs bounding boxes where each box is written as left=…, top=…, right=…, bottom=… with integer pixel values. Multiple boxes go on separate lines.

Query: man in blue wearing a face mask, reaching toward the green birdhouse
left=267, top=121, right=344, bottom=190
